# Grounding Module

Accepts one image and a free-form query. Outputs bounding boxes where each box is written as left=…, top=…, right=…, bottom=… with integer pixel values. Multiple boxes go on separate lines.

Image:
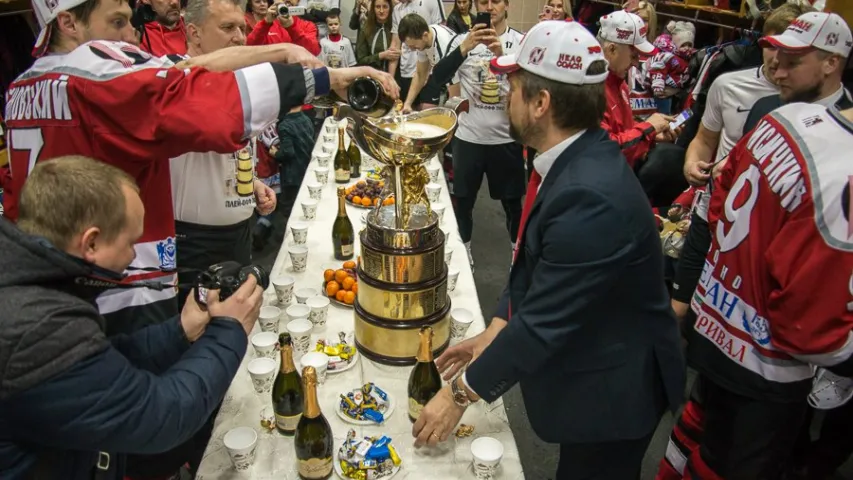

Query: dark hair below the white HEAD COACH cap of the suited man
left=518, top=60, right=607, bottom=130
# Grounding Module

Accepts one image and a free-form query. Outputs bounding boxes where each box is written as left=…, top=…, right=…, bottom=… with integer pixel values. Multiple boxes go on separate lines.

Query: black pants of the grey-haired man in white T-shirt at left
left=175, top=219, right=252, bottom=309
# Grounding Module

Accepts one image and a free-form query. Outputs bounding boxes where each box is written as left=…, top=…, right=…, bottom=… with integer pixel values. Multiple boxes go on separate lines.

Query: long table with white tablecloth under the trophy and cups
left=197, top=119, right=524, bottom=480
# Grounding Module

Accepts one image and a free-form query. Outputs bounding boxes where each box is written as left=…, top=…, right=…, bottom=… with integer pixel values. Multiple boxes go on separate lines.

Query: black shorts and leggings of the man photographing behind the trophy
left=453, top=138, right=527, bottom=243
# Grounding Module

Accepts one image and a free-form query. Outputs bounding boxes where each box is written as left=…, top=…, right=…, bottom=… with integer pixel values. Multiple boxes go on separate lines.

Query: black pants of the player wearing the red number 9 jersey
left=687, top=375, right=807, bottom=480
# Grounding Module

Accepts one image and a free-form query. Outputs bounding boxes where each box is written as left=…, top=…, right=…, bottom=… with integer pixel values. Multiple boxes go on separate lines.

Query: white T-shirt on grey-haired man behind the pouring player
left=169, top=138, right=257, bottom=226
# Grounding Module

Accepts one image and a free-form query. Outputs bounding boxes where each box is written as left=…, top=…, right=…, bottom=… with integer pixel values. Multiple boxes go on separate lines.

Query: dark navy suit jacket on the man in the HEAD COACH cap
left=467, top=128, right=685, bottom=443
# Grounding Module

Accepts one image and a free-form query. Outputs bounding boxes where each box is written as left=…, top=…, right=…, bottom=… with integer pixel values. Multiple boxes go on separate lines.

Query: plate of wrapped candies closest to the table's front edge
left=335, top=430, right=403, bottom=480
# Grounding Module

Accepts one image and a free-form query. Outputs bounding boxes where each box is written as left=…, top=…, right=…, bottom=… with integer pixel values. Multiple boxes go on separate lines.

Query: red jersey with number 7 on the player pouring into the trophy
left=4, top=41, right=320, bottom=330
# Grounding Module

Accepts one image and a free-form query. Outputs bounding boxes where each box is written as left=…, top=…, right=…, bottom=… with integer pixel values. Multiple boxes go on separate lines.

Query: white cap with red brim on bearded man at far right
left=758, top=12, right=853, bottom=58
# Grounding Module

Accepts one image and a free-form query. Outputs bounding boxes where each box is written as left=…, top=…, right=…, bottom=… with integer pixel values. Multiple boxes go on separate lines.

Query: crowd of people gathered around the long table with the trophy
left=0, top=0, right=853, bottom=480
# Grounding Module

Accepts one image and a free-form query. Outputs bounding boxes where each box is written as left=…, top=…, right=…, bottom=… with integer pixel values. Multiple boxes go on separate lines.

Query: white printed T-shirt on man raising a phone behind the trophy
left=449, top=27, right=524, bottom=145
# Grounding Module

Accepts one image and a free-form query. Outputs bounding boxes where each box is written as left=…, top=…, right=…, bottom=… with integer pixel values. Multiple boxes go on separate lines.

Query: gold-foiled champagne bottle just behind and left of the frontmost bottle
left=272, top=333, right=304, bottom=436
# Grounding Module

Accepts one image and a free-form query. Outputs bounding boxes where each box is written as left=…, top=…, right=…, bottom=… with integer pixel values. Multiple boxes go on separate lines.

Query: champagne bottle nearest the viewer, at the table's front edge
left=294, top=367, right=334, bottom=480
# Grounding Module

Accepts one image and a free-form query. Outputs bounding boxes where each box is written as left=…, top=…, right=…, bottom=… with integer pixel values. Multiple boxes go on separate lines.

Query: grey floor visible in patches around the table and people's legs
left=250, top=183, right=853, bottom=480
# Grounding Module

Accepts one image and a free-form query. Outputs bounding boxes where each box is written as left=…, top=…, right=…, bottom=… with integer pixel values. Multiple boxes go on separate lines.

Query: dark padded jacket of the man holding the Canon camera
left=0, top=219, right=246, bottom=480
